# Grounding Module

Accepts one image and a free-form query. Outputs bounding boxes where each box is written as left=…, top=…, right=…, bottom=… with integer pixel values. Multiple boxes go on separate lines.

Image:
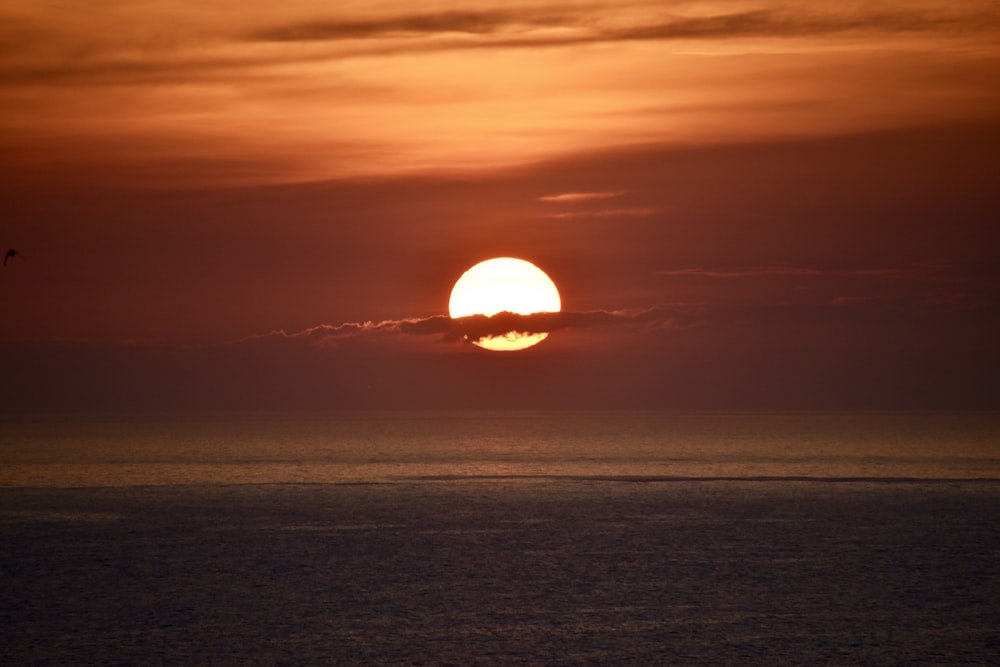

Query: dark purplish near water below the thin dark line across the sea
left=0, top=481, right=1000, bottom=665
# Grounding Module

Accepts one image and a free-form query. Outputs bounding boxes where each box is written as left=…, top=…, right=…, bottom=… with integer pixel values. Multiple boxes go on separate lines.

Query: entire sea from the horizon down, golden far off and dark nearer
left=0, top=411, right=1000, bottom=665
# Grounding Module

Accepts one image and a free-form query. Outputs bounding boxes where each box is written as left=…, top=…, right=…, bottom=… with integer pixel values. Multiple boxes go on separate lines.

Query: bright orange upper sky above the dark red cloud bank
left=0, top=0, right=1000, bottom=185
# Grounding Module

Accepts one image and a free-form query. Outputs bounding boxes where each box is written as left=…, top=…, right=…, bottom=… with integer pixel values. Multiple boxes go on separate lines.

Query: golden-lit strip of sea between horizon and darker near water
left=0, top=410, right=1000, bottom=486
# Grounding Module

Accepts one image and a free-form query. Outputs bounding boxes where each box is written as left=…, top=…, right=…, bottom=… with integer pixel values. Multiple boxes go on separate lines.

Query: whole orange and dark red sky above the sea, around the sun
left=0, top=0, right=1000, bottom=412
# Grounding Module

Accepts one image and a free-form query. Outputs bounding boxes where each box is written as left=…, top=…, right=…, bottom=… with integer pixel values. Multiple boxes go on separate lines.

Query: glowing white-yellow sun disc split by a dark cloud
left=448, top=257, right=562, bottom=351
